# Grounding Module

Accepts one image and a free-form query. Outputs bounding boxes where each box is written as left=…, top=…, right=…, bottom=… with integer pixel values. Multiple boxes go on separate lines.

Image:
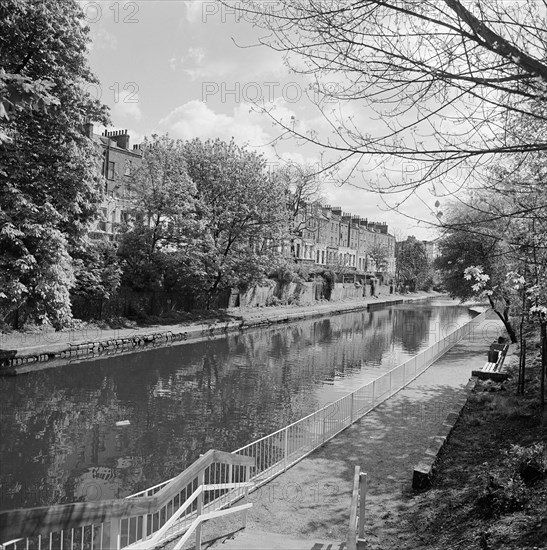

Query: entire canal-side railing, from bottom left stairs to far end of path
left=0, top=311, right=488, bottom=550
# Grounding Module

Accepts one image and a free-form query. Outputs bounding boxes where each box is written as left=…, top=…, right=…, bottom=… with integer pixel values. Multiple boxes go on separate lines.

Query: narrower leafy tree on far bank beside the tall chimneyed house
left=119, top=135, right=197, bottom=290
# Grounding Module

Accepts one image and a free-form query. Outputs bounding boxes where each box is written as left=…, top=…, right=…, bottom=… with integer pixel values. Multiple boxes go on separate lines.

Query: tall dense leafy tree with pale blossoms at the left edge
left=0, top=0, right=107, bottom=328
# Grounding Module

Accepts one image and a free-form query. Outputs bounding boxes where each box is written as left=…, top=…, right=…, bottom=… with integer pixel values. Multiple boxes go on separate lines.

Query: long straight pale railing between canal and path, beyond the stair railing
left=234, top=311, right=488, bottom=488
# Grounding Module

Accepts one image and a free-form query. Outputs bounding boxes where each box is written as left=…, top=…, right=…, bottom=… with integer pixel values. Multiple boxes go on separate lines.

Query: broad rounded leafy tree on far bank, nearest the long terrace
left=184, top=139, right=287, bottom=306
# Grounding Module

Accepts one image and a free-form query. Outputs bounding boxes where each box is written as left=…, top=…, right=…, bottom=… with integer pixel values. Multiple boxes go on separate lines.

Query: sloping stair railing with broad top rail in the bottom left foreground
left=0, top=450, right=254, bottom=550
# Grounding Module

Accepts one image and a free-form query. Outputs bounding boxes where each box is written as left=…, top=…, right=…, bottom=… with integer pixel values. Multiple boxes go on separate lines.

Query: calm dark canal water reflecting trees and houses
left=0, top=300, right=471, bottom=509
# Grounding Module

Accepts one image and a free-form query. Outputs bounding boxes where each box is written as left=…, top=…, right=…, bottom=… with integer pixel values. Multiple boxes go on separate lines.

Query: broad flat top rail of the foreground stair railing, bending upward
left=0, top=450, right=255, bottom=540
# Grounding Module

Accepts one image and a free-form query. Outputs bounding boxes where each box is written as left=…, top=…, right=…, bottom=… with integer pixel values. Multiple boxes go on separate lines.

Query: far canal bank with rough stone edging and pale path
left=0, top=292, right=442, bottom=376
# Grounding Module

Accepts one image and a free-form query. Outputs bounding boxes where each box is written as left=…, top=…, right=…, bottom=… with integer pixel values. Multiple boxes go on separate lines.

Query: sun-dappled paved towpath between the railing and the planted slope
left=196, top=315, right=503, bottom=550
